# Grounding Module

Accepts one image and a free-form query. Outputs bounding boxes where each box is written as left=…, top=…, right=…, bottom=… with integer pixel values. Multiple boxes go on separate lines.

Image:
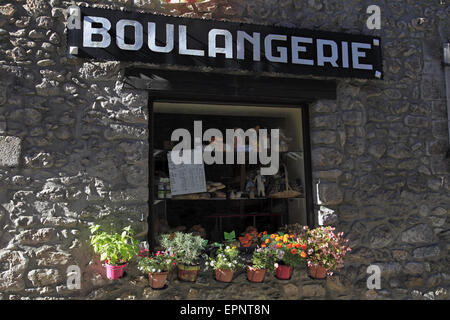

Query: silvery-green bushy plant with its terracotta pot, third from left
left=160, top=232, right=205, bottom=282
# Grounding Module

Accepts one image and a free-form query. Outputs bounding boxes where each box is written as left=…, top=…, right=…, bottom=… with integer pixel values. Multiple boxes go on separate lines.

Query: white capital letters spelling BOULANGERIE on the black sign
left=76, top=8, right=381, bottom=78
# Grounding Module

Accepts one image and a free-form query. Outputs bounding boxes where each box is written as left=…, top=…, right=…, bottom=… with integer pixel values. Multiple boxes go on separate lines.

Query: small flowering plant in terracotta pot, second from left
left=138, top=251, right=175, bottom=289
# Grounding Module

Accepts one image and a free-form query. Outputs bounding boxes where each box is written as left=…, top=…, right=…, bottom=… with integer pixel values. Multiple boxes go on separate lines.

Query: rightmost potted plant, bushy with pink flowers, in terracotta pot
left=306, top=226, right=351, bottom=279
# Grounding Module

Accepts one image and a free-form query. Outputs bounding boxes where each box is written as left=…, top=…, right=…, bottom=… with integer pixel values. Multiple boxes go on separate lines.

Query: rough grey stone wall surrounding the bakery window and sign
left=0, top=0, right=450, bottom=299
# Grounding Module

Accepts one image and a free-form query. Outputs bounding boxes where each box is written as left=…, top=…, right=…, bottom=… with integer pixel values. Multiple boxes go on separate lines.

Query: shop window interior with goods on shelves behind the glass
left=150, top=102, right=307, bottom=242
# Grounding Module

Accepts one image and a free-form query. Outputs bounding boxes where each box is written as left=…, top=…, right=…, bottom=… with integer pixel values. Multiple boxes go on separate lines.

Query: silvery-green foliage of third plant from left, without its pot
left=160, top=232, right=206, bottom=265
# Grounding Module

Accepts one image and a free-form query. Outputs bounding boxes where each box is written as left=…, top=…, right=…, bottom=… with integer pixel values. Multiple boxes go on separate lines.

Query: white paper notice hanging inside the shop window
left=167, top=152, right=206, bottom=196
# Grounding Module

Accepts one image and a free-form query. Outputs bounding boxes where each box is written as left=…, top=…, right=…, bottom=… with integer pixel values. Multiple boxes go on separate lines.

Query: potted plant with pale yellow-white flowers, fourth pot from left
left=205, top=246, right=242, bottom=282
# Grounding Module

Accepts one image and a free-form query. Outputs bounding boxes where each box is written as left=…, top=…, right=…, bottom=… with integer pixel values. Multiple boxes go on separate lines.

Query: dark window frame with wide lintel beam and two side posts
left=121, top=68, right=336, bottom=250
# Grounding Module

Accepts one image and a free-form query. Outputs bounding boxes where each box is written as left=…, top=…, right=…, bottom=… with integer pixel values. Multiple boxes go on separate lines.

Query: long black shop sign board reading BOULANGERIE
left=67, top=6, right=383, bottom=79
